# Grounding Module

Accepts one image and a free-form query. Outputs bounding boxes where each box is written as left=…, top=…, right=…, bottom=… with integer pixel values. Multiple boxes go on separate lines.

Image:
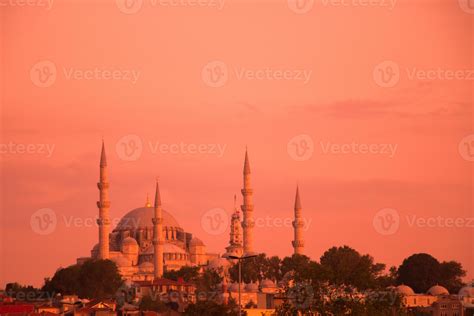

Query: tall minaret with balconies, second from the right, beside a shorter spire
left=241, top=150, right=255, bottom=253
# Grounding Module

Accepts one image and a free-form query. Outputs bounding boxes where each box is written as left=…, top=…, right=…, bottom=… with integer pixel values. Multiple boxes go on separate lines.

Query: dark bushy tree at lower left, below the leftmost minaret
left=43, top=260, right=123, bottom=299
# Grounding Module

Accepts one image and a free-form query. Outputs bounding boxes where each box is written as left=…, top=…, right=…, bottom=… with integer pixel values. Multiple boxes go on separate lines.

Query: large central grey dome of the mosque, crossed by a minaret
left=114, top=207, right=181, bottom=230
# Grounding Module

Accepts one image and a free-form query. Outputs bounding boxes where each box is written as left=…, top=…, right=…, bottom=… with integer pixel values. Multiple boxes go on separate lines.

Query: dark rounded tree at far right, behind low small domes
left=397, top=253, right=466, bottom=293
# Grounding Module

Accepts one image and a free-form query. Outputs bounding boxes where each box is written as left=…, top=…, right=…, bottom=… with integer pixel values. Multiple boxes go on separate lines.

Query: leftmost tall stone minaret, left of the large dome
left=97, top=141, right=110, bottom=259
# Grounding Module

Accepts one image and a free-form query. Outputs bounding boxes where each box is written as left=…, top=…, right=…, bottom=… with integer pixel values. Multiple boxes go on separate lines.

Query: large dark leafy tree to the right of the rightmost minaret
left=321, top=246, right=385, bottom=290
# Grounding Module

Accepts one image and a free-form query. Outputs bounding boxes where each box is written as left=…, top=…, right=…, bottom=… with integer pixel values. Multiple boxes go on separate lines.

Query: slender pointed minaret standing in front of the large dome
left=152, top=180, right=164, bottom=278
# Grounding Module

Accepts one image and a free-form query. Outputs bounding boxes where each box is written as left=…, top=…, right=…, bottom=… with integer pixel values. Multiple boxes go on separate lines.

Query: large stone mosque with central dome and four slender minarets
left=77, top=142, right=304, bottom=281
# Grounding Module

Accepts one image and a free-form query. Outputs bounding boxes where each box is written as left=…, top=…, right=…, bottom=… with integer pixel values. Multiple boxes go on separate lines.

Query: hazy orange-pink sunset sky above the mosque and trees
left=0, top=0, right=474, bottom=287
